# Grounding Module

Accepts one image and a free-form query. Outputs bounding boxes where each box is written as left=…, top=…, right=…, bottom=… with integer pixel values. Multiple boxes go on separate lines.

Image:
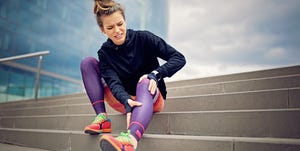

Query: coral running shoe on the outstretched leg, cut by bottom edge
left=100, top=130, right=134, bottom=151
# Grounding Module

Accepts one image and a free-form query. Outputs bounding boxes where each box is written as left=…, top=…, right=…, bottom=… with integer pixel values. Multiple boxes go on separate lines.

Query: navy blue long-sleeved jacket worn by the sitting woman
left=98, top=29, right=186, bottom=112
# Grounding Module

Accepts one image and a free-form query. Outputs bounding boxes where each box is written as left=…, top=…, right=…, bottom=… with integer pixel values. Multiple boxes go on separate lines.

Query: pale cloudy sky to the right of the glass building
left=168, top=0, right=300, bottom=81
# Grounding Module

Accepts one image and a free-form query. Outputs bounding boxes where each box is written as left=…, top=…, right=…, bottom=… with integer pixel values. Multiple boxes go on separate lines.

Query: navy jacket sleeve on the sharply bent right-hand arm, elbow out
left=146, top=32, right=186, bottom=78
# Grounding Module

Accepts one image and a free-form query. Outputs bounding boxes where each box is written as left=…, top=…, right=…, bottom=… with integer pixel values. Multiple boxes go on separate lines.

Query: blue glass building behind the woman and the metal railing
left=0, top=0, right=168, bottom=102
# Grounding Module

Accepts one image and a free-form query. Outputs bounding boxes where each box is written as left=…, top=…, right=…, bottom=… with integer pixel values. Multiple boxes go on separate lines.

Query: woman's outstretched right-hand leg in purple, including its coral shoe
left=100, top=79, right=164, bottom=151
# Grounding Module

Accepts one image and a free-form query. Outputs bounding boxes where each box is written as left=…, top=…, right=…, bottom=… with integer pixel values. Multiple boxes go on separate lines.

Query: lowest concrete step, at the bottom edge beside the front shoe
left=0, top=128, right=300, bottom=151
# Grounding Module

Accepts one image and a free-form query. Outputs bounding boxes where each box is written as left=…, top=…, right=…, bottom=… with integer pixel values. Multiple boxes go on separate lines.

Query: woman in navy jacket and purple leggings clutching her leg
left=81, top=0, right=185, bottom=151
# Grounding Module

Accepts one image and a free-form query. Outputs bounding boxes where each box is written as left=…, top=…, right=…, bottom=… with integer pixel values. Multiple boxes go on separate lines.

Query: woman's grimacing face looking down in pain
left=101, top=11, right=126, bottom=45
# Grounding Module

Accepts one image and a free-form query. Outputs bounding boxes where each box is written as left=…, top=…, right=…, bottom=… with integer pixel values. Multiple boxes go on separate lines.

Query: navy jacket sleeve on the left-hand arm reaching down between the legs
left=98, top=52, right=131, bottom=113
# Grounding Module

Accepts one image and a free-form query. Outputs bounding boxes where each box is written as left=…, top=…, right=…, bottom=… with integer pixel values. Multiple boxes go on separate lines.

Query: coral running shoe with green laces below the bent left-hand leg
left=84, top=113, right=111, bottom=135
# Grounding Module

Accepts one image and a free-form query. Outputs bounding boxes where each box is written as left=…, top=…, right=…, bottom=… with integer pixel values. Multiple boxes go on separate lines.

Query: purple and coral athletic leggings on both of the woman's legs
left=80, top=57, right=164, bottom=141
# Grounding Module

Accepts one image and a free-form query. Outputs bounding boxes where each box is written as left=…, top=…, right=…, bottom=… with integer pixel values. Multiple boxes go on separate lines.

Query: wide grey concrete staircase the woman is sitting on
left=0, top=66, right=300, bottom=151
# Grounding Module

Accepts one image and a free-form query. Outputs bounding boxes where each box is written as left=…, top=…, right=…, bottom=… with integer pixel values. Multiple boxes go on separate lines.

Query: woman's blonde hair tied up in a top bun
left=94, top=0, right=125, bottom=27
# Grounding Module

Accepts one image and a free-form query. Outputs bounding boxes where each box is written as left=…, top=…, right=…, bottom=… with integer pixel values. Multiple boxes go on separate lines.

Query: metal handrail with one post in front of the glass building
left=0, top=50, right=50, bottom=100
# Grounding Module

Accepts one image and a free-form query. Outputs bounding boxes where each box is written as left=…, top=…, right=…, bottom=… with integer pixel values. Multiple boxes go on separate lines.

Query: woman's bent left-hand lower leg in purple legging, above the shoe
left=80, top=57, right=106, bottom=115
